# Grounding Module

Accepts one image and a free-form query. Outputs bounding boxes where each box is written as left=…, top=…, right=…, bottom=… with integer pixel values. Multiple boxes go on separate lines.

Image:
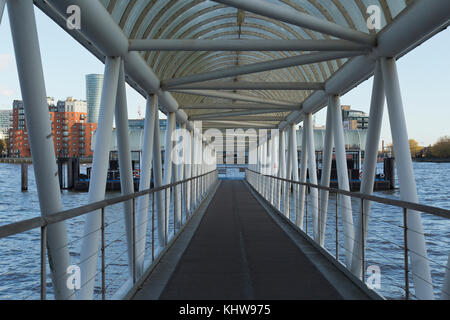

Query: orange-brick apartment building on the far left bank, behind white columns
left=9, top=98, right=97, bottom=158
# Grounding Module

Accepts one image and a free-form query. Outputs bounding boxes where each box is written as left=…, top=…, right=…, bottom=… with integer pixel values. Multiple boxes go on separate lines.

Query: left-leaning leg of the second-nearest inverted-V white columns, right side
left=319, top=101, right=333, bottom=247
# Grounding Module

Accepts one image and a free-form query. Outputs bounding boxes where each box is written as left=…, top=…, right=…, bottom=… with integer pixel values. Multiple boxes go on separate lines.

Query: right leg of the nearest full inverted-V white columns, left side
left=115, top=61, right=134, bottom=276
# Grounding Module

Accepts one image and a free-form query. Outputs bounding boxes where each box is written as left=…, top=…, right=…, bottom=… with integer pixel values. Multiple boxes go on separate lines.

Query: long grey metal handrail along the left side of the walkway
left=0, top=169, right=217, bottom=239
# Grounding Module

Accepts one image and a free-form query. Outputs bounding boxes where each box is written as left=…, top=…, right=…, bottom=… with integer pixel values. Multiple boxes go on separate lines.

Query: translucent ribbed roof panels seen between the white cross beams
left=96, top=0, right=412, bottom=120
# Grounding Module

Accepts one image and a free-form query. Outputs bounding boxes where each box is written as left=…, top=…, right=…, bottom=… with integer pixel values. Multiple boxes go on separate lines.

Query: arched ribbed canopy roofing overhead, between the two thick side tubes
left=94, top=0, right=412, bottom=125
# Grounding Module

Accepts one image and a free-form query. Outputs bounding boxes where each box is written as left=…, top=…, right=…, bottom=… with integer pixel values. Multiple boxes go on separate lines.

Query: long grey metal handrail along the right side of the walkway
left=247, top=169, right=450, bottom=219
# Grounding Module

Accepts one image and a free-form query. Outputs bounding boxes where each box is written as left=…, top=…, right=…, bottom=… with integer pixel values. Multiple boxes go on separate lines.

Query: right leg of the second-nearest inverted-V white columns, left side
left=153, top=111, right=166, bottom=246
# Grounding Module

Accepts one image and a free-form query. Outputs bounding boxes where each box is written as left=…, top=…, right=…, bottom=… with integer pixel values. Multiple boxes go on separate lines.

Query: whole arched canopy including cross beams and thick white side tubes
left=34, top=0, right=449, bottom=130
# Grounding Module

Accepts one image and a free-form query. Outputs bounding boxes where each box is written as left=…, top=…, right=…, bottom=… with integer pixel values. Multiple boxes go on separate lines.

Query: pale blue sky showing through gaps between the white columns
left=0, top=8, right=450, bottom=146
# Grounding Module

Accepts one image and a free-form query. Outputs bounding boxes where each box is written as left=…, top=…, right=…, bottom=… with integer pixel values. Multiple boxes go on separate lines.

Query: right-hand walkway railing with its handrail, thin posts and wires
left=246, top=169, right=450, bottom=299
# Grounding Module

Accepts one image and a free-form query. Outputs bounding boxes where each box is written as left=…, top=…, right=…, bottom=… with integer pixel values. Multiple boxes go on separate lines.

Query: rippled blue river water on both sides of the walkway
left=0, top=163, right=450, bottom=299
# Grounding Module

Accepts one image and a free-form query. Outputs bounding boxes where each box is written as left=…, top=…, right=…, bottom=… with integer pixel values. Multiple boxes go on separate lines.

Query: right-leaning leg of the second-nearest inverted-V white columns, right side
left=328, top=96, right=355, bottom=267
